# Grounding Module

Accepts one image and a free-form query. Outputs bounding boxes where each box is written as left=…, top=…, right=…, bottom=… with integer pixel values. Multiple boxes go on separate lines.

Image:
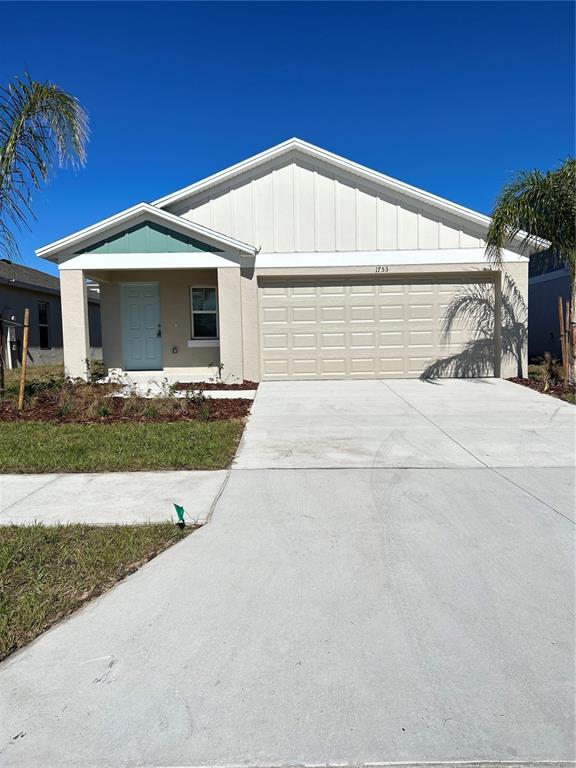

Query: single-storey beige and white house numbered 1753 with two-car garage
left=37, top=139, right=544, bottom=380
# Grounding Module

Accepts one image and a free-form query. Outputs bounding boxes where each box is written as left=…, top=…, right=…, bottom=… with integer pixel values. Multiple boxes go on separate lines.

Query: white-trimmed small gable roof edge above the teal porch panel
left=36, top=203, right=257, bottom=259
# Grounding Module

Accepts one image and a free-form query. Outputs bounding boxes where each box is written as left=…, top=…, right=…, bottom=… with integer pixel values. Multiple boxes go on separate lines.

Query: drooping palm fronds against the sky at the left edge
left=0, top=75, right=88, bottom=259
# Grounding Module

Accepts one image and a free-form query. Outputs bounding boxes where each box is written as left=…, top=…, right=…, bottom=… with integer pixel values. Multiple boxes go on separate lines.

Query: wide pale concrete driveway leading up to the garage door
left=0, top=380, right=576, bottom=768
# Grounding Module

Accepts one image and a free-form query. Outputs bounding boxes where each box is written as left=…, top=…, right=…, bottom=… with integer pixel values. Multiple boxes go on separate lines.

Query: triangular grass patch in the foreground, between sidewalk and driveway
left=0, top=523, right=192, bottom=659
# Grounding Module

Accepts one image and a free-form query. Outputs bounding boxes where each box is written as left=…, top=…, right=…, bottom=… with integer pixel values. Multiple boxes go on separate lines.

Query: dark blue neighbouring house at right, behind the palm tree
left=528, top=252, right=571, bottom=359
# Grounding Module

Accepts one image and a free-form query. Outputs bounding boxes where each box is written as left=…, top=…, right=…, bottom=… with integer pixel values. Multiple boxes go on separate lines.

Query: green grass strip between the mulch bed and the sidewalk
left=0, top=421, right=243, bottom=472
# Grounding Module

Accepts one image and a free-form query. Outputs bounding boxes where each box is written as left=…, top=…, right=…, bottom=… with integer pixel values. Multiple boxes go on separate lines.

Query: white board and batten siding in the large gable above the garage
left=170, top=160, right=484, bottom=253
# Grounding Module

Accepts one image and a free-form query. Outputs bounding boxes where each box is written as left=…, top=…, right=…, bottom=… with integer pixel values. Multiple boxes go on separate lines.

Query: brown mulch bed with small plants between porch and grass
left=0, top=395, right=253, bottom=424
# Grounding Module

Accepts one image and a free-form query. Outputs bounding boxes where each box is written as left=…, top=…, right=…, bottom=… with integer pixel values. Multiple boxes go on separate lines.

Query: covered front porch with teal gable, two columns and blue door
left=37, top=203, right=256, bottom=381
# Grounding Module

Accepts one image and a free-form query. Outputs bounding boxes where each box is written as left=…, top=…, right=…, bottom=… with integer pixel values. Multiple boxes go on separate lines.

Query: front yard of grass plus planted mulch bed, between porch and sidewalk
left=0, top=366, right=252, bottom=472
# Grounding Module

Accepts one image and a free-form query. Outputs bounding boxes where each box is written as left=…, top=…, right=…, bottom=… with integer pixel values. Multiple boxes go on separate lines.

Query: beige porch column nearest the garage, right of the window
left=218, top=267, right=244, bottom=381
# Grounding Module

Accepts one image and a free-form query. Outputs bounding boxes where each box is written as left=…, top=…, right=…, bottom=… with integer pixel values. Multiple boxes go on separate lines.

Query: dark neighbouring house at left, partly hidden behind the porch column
left=0, top=259, right=102, bottom=368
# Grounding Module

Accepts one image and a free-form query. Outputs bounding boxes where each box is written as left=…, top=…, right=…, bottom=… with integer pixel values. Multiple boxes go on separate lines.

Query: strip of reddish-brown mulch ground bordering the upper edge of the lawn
left=0, top=394, right=253, bottom=424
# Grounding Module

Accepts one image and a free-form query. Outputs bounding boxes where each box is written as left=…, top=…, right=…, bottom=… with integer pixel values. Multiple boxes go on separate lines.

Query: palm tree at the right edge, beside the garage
left=486, top=157, right=576, bottom=384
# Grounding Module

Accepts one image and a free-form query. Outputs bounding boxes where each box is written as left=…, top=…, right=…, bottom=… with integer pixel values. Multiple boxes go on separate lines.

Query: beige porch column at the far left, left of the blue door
left=60, top=269, right=90, bottom=379
